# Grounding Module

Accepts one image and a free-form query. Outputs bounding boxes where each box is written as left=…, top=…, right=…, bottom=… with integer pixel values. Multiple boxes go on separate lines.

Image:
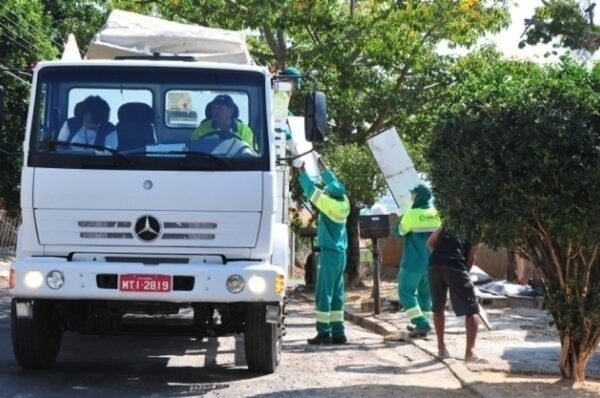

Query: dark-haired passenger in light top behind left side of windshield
left=58, top=96, right=118, bottom=149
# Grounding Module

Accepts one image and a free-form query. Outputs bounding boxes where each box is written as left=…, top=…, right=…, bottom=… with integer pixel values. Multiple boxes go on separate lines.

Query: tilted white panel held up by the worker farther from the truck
left=367, top=127, right=422, bottom=214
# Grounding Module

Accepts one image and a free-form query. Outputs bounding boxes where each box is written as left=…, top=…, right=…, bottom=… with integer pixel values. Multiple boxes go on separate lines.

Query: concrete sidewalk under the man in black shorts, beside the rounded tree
left=302, top=291, right=600, bottom=398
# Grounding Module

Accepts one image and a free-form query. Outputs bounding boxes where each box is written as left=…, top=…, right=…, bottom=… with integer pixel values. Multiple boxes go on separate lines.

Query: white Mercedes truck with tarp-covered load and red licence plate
left=0, top=11, right=325, bottom=373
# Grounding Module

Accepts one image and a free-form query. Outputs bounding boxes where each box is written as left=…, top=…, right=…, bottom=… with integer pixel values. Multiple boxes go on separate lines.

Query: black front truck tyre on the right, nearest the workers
left=244, top=304, right=282, bottom=373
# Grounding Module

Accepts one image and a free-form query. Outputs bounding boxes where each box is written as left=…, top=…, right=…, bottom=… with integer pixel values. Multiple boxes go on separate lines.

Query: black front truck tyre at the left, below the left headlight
left=10, top=299, right=62, bottom=369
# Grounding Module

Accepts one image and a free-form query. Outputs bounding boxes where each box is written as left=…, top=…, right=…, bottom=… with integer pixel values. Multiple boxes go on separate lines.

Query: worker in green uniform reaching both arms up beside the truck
left=294, top=158, right=350, bottom=344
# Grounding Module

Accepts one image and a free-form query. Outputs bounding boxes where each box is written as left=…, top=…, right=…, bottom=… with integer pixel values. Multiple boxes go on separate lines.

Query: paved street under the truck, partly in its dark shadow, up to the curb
left=0, top=289, right=474, bottom=398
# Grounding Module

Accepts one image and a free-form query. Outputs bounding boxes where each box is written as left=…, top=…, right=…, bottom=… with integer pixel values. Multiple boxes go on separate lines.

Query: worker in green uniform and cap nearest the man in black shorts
left=394, top=185, right=441, bottom=337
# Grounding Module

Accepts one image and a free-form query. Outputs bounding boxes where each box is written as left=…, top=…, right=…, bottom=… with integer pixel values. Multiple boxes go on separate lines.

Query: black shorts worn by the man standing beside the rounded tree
left=429, top=265, right=479, bottom=316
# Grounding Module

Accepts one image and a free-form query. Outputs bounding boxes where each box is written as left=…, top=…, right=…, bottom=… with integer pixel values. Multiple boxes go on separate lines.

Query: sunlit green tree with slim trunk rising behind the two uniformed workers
left=112, top=0, right=508, bottom=281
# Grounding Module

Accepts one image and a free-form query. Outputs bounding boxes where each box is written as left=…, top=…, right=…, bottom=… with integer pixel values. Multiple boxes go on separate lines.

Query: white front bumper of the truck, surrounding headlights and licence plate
left=10, top=257, right=285, bottom=303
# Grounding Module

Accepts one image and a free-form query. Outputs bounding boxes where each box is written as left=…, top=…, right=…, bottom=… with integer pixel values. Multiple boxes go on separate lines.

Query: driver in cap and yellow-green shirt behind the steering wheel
left=190, top=94, right=255, bottom=148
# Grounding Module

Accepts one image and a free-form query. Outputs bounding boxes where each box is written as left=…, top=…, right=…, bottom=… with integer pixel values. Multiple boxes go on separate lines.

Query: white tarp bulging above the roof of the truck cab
left=87, top=10, right=252, bottom=64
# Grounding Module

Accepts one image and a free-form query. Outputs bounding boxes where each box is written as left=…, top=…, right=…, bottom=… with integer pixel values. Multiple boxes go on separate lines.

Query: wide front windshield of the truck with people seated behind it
left=28, top=63, right=269, bottom=170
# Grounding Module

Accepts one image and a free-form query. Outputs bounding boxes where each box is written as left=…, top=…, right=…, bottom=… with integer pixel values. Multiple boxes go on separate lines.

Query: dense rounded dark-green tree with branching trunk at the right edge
left=427, top=52, right=600, bottom=381
